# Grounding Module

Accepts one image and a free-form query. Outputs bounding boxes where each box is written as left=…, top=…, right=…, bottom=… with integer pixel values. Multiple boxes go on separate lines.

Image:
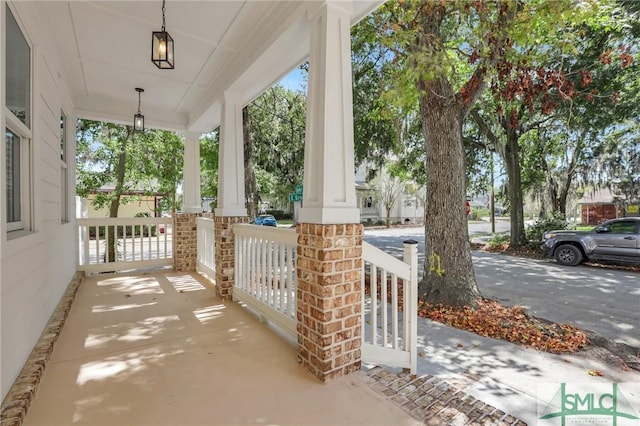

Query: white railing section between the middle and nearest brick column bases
left=233, top=224, right=297, bottom=339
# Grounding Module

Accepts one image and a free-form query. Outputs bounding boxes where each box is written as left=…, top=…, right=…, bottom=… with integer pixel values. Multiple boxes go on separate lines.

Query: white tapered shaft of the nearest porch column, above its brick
left=299, top=1, right=360, bottom=224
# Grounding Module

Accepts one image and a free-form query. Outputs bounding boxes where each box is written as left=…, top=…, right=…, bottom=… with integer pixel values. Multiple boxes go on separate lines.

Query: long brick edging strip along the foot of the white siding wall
left=0, top=272, right=84, bottom=426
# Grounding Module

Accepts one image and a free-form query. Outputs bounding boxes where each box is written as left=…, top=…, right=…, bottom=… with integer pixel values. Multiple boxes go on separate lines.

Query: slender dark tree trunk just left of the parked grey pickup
left=504, top=129, right=526, bottom=247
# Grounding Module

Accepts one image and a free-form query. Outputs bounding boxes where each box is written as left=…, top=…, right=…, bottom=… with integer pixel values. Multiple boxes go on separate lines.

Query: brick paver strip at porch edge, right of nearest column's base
left=356, top=367, right=526, bottom=426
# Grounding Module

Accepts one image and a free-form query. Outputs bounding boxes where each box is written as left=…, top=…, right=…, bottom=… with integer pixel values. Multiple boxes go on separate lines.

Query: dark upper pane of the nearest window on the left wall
left=5, top=5, right=31, bottom=128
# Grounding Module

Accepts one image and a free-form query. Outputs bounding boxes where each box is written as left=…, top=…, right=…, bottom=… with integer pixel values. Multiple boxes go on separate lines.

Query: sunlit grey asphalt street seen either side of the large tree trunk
left=364, top=222, right=640, bottom=347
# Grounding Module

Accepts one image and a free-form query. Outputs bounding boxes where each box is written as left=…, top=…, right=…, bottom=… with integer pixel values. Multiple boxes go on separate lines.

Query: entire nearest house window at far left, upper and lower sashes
left=3, top=5, right=32, bottom=236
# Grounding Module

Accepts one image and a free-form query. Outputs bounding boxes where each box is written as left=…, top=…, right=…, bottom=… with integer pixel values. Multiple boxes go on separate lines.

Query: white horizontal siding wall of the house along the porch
left=0, top=1, right=76, bottom=399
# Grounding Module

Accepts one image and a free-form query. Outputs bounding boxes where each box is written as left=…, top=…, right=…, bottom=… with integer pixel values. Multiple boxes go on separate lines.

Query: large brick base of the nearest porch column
left=296, top=223, right=362, bottom=382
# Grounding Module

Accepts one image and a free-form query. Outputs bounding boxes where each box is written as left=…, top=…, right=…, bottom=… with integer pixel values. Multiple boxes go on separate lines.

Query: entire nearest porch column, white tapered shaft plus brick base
left=296, top=1, right=363, bottom=382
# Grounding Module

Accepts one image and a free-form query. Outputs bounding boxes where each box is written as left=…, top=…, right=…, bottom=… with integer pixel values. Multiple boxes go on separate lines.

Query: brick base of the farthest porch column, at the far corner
left=173, top=213, right=202, bottom=272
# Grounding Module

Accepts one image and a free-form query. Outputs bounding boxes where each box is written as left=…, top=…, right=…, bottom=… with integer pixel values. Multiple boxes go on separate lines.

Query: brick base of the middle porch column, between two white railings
left=213, top=216, right=249, bottom=299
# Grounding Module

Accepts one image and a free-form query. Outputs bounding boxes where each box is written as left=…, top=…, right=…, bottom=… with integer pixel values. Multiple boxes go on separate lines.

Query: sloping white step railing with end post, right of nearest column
left=362, top=241, right=418, bottom=374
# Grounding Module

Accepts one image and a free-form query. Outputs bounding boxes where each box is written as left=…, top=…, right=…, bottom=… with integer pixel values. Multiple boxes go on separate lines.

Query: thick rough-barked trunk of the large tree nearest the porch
left=418, top=78, right=480, bottom=307
